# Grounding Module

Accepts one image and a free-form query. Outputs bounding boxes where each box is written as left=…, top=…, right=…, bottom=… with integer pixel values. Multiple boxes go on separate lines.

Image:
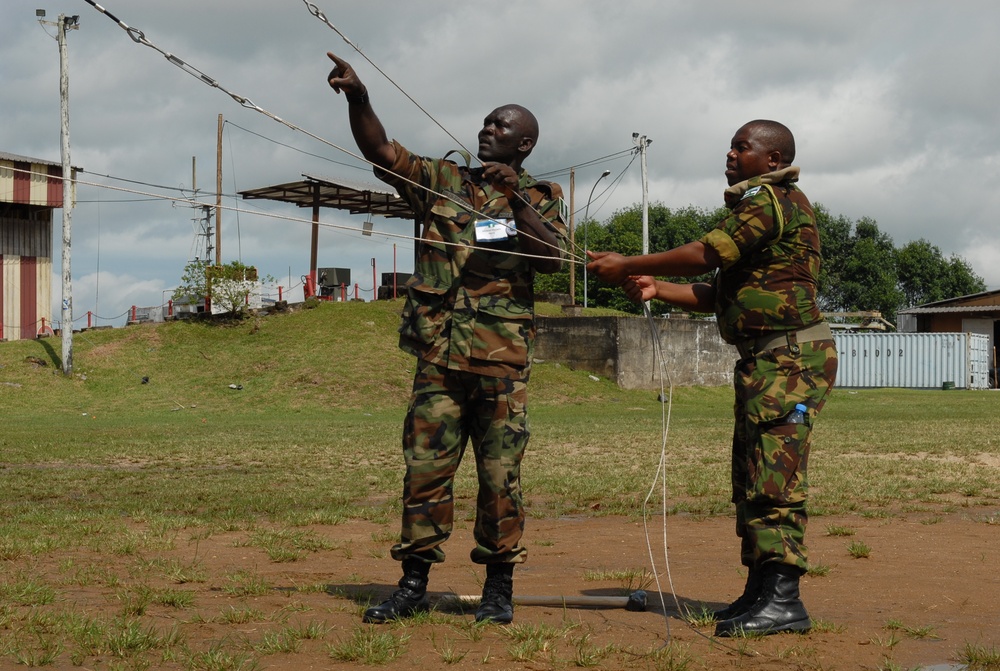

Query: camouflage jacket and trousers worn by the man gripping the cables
left=702, top=168, right=837, bottom=571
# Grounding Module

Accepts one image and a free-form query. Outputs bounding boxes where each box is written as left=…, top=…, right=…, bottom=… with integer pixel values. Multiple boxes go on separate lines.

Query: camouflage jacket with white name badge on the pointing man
left=376, top=142, right=566, bottom=379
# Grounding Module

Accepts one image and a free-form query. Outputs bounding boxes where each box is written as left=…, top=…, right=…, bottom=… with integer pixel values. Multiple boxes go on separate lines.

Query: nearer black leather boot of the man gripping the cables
left=715, top=562, right=812, bottom=636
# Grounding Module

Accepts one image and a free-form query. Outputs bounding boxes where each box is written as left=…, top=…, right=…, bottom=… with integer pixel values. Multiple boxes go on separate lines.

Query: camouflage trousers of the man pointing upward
left=392, top=362, right=529, bottom=564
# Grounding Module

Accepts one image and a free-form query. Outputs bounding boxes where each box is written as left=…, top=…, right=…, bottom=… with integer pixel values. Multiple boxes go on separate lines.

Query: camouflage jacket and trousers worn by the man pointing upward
left=376, top=142, right=565, bottom=564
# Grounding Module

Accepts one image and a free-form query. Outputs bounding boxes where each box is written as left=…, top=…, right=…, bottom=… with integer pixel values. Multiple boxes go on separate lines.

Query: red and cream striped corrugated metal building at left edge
left=0, top=152, right=76, bottom=340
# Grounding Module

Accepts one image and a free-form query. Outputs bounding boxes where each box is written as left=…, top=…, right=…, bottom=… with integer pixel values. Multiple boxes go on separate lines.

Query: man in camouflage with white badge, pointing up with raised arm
left=329, top=54, right=565, bottom=623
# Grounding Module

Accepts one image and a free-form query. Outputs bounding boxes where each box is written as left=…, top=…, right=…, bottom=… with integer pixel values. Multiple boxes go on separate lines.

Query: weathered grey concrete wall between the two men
left=535, top=317, right=737, bottom=389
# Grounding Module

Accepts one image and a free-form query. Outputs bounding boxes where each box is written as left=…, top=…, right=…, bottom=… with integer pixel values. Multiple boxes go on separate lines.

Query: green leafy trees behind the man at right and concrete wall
left=535, top=203, right=986, bottom=323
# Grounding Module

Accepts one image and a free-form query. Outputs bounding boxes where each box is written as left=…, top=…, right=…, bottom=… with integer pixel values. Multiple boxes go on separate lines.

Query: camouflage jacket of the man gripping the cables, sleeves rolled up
left=701, top=167, right=823, bottom=343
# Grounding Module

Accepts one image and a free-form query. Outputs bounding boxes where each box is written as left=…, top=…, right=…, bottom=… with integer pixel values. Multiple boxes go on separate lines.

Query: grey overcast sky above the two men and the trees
left=0, top=0, right=1000, bottom=327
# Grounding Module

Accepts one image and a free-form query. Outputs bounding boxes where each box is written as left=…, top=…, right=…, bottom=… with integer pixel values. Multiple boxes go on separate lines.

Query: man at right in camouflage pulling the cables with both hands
left=587, top=120, right=837, bottom=636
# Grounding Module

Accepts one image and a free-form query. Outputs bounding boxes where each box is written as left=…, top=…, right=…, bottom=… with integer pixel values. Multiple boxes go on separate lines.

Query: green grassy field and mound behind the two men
left=0, top=301, right=1000, bottom=669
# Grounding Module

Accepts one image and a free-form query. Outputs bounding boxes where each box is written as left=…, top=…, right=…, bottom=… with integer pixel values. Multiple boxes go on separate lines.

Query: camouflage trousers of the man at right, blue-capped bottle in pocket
left=732, top=340, right=837, bottom=572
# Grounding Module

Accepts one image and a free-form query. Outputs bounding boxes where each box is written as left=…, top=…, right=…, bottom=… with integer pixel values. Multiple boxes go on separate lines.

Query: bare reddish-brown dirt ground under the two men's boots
left=17, top=513, right=1000, bottom=671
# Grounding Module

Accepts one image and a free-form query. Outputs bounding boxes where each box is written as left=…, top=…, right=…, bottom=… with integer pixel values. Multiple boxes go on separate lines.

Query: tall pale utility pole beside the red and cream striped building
left=35, top=9, right=80, bottom=375
